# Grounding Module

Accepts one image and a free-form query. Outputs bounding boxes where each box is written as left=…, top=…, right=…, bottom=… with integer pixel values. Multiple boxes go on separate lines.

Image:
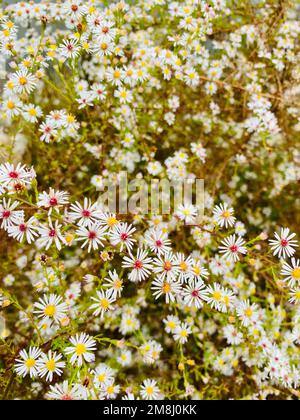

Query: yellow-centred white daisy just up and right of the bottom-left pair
left=65, top=333, right=96, bottom=366
